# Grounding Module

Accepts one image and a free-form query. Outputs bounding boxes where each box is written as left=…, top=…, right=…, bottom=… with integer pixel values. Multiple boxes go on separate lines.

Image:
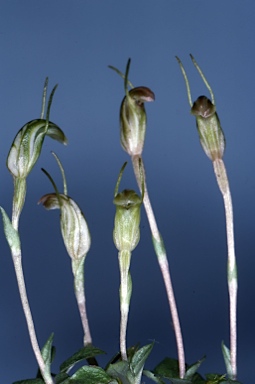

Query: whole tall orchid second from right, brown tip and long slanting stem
left=110, top=59, right=185, bottom=378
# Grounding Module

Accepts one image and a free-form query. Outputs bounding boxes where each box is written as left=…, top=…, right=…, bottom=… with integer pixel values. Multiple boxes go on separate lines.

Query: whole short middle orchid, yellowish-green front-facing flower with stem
left=113, top=163, right=143, bottom=361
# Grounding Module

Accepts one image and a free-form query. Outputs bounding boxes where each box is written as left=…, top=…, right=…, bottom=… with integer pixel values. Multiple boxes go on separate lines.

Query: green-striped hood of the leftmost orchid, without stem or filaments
left=6, top=119, right=67, bottom=178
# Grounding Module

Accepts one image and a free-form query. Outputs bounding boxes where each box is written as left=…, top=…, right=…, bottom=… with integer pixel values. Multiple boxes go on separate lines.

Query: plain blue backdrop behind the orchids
left=0, top=0, right=255, bottom=384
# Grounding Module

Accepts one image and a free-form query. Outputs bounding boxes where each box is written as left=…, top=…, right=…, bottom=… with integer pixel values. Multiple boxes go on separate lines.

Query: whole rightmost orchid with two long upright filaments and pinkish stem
left=177, top=55, right=238, bottom=380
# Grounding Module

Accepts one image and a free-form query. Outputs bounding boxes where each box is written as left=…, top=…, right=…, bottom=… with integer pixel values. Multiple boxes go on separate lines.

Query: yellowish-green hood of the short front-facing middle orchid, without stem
left=113, top=189, right=142, bottom=252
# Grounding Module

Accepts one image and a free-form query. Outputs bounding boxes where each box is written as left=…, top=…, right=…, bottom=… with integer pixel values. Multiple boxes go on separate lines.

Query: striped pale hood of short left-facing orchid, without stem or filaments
left=39, top=193, right=91, bottom=260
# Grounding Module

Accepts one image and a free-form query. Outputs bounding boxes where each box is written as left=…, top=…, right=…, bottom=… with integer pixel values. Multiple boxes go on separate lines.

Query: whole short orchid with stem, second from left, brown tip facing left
left=39, top=153, right=92, bottom=346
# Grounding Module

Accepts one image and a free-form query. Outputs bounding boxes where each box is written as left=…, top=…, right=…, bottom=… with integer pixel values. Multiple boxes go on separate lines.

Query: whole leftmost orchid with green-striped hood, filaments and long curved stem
left=1, top=79, right=67, bottom=384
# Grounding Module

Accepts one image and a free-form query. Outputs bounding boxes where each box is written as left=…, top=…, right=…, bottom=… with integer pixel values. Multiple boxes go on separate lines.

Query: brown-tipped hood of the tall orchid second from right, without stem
left=120, top=87, right=155, bottom=156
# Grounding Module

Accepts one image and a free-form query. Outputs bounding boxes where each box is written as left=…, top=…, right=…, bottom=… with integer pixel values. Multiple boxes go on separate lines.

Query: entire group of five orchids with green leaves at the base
left=0, top=56, right=238, bottom=384
